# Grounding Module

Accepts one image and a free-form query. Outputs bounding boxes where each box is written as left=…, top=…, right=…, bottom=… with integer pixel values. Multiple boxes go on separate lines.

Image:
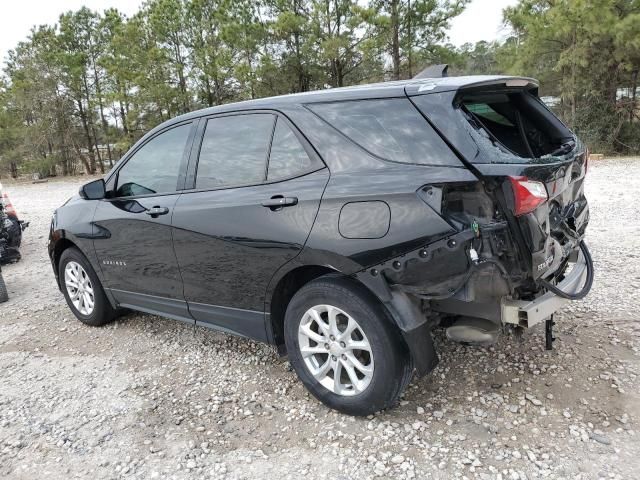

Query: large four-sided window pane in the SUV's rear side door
left=196, top=113, right=275, bottom=189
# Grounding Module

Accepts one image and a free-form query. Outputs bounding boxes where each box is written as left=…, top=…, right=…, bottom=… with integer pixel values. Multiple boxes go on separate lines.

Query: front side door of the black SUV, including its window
left=94, top=123, right=192, bottom=319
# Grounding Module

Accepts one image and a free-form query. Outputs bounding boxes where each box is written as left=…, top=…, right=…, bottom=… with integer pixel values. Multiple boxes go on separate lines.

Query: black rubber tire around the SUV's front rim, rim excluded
left=58, top=247, right=117, bottom=327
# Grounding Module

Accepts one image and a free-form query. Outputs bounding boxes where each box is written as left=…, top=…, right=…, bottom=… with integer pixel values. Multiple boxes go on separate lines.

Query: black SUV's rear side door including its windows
left=173, top=112, right=329, bottom=340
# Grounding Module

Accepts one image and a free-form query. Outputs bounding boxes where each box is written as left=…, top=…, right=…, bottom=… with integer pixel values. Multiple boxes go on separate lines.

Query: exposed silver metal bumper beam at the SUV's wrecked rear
left=501, top=248, right=587, bottom=328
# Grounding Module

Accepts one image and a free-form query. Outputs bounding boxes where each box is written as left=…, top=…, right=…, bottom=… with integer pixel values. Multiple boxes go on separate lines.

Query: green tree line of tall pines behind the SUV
left=0, top=0, right=640, bottom=177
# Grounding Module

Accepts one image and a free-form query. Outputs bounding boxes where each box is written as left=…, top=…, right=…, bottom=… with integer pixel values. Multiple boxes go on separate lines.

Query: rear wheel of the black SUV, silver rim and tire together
left=284, top=275, right=413, bottom=416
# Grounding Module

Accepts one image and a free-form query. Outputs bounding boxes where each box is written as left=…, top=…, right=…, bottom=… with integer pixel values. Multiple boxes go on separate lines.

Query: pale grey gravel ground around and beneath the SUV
left=0, top=159, right=640, bottom=480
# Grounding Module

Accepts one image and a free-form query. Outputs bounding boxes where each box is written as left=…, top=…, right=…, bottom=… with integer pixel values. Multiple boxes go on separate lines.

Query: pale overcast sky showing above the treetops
left=0, top=0, right=517, bottom=63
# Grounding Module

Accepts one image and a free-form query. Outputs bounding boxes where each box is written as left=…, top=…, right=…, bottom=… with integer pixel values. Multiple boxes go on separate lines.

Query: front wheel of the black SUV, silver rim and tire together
left=58, top=248, right=117, bottom=327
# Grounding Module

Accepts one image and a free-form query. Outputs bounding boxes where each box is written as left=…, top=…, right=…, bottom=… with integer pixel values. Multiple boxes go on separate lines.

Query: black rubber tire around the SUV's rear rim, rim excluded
left=284, top=276, right=412, bottom=416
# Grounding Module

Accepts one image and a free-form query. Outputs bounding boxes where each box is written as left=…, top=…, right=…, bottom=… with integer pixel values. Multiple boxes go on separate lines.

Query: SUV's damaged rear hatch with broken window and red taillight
left=406, top=77, right=589, bottom=279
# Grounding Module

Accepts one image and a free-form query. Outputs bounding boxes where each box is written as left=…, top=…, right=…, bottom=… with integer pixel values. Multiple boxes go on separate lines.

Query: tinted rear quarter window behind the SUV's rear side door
left=308, top=98, right=459, bottom=166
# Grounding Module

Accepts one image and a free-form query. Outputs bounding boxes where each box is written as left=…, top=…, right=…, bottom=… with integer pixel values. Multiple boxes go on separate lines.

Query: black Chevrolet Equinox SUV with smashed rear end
left=49, top=76, right=593, bottom=415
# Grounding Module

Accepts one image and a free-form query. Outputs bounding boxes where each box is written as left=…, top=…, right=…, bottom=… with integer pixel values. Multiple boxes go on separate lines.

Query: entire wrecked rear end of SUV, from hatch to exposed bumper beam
left=398, top=77, right=593, bottom=344
